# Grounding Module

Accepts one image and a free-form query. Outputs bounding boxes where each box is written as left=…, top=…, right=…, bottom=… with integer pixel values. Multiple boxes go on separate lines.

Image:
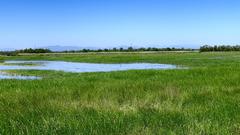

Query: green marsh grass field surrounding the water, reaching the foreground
left=0, top=52, right=240, bottom=135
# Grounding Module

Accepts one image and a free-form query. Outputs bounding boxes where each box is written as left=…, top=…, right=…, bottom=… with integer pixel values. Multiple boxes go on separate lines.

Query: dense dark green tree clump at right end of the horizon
left=200, top=45, right=240, bottom=52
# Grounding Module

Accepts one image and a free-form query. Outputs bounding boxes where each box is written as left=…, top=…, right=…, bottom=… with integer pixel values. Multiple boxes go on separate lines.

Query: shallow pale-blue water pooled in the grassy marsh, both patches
left=0, top=61, right=177, bottom=79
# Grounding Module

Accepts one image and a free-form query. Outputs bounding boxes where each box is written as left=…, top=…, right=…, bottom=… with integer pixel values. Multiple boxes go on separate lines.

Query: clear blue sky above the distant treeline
left=0, top=0, right=240, bottom=48
